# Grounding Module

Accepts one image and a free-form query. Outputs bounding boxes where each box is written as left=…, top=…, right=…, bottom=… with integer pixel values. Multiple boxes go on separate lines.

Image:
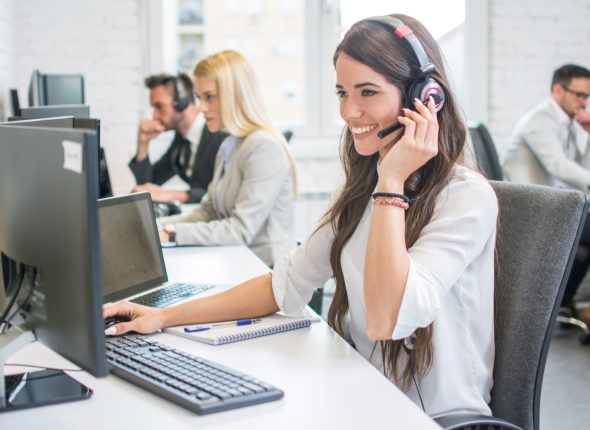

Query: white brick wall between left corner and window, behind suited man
left=9, top=0, right=146, bottom=192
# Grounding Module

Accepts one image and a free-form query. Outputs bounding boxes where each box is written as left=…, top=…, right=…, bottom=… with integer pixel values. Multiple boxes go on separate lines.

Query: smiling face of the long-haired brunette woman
left=336, top=53, right=403, bottom=158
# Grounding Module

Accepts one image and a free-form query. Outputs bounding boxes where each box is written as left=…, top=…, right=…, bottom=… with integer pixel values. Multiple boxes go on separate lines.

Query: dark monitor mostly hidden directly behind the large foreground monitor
left=6, top=116, right=113, bottom=199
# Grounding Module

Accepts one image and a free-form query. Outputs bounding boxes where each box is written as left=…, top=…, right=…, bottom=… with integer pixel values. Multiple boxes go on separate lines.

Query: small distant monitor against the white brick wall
left=29, top=70, right=85, bottom=106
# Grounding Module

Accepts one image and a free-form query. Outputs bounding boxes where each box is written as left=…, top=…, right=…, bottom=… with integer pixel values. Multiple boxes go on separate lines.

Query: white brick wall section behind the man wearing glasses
left=488, top=0, right=590, bottom=154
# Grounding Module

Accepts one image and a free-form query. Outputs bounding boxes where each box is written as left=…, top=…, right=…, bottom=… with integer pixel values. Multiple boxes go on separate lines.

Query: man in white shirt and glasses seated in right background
left=504, top=64, right=590, bottom=323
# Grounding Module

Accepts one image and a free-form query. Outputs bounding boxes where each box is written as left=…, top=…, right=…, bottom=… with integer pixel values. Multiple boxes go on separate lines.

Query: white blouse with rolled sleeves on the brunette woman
left=272, top=166, right=498, bottom=416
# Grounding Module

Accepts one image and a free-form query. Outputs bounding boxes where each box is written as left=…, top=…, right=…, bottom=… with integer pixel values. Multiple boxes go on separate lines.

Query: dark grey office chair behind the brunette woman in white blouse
left=436, top=182, right=589, bottom=430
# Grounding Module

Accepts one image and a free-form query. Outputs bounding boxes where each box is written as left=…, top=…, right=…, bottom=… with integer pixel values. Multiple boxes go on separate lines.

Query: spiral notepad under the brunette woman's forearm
left=164, top=313, right=319, bottom=345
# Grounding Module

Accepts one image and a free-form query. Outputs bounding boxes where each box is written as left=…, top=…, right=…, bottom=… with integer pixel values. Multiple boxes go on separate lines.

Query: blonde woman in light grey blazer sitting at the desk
left=160, top=51, right=296, bottom=265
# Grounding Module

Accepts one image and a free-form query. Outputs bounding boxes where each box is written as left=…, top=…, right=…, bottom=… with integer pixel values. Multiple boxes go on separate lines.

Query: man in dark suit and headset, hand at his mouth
left=129, top=74, right=226, bottom=203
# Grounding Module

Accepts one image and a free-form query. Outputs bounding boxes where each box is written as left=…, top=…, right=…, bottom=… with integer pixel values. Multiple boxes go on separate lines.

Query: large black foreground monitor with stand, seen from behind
left=0, top=125, right=107, bottom=411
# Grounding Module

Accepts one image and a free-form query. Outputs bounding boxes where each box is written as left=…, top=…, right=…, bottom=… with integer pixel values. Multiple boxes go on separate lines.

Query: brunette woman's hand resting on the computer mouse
left=102, top=301, right=164, bottom=335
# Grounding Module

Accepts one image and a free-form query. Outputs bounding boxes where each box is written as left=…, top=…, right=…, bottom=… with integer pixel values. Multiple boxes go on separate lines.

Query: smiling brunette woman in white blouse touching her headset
left=104, top=15, right=498, bottom=416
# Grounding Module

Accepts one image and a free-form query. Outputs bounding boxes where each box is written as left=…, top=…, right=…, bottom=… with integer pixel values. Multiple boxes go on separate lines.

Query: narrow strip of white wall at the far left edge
left=0, top=0, right=15, bottom=119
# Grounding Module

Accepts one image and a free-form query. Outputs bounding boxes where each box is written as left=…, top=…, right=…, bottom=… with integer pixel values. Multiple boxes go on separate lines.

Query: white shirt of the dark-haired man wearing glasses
left=503, top=98, right=590, bottom=192
